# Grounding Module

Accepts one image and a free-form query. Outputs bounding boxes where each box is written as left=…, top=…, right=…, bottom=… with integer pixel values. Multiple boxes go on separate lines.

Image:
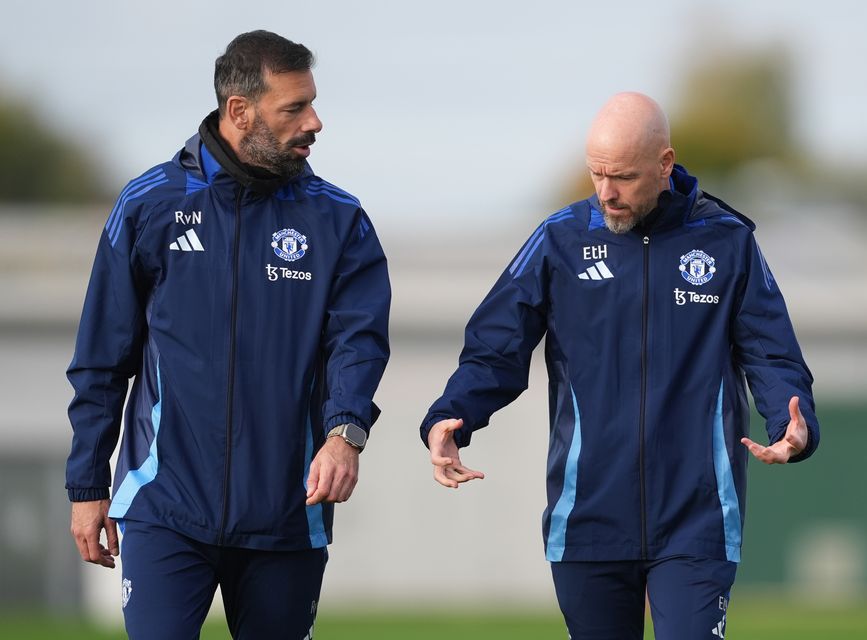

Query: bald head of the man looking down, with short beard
left=587, top=93, right=674, bottom=233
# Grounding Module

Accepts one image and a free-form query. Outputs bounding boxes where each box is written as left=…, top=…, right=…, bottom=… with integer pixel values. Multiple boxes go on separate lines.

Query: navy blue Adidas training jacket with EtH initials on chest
left=421, top=166, right=819, bottom=562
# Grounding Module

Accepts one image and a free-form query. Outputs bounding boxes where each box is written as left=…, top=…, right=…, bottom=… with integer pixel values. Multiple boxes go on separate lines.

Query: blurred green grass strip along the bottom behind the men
left=0, top=594, right=867, bottom=640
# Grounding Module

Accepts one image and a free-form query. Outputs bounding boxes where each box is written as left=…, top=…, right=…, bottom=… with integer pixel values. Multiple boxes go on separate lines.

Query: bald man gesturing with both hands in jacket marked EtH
left=421, top=93, right=819, bottom=640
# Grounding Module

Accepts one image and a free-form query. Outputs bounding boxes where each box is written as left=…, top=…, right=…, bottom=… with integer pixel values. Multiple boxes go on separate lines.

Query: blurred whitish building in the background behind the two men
left=0, top=209, right=867, bottom=618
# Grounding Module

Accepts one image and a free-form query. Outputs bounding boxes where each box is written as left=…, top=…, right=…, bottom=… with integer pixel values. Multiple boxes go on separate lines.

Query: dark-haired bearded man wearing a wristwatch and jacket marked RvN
left=66, top=31, right=390, bottom=640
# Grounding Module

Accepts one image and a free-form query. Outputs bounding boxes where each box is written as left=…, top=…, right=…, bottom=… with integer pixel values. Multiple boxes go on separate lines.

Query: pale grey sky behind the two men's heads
left=0, top=0, right=867, bottom=227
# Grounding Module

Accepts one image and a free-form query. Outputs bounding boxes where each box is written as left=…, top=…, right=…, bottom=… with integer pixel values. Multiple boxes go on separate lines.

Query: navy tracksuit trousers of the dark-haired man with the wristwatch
left=121, top=520, right=328, bottom=640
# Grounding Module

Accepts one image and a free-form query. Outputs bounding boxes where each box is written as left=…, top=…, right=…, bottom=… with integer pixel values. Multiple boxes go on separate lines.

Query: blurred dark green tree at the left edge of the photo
left=0, top=98, right=106, bottom=203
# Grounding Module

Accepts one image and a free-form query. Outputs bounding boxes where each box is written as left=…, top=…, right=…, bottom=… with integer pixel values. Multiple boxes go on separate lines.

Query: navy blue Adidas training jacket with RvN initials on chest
left=66, top=114, right=391, bottom=550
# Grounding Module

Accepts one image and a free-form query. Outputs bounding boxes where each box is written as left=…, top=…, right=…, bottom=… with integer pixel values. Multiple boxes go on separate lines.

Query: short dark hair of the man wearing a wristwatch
left=214, top=30, right=314, bottom=115
